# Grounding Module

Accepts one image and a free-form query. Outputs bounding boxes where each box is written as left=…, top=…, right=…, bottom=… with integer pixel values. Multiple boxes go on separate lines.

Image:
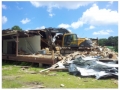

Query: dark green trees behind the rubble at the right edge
left=98, top=36, right=118, bottom=51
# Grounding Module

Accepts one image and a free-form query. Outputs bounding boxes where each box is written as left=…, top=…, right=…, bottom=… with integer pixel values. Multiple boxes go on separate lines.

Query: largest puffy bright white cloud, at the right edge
left=80, top=4, right=118, bottom=25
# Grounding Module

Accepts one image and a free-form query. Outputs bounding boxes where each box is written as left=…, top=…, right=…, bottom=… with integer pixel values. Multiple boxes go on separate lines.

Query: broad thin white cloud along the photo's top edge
left=30, top=1, right=93, bottom=16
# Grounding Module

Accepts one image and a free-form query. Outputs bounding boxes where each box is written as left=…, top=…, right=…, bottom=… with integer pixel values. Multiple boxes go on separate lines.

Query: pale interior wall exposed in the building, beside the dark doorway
left=3, top=35, right=41, bottom=54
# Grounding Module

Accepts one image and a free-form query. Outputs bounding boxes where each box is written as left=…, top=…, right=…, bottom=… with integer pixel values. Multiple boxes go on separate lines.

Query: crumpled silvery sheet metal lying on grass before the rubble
left=68, top=56, right=118, bottom=79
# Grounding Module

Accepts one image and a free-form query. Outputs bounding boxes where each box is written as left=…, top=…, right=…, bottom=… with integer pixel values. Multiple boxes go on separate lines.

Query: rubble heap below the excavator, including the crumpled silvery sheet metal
left=41, top=47, right=118, bottom=79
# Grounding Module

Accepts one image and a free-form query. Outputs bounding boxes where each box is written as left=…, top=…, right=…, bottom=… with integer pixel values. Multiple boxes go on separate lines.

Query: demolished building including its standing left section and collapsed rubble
left=2, top=29, right=118, bottom=79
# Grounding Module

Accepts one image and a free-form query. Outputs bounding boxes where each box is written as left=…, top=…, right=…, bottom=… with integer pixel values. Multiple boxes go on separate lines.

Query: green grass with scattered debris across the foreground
left=2, top=61, right=118, bottom=89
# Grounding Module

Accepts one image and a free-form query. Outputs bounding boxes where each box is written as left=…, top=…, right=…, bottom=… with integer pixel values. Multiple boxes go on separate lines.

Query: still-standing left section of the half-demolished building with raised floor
left=2, top=30, right=55, bottom=65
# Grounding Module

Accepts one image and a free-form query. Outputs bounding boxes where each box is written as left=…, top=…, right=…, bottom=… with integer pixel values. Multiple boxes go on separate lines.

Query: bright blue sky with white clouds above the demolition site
left=2, top=1, right=118, bottom=38
